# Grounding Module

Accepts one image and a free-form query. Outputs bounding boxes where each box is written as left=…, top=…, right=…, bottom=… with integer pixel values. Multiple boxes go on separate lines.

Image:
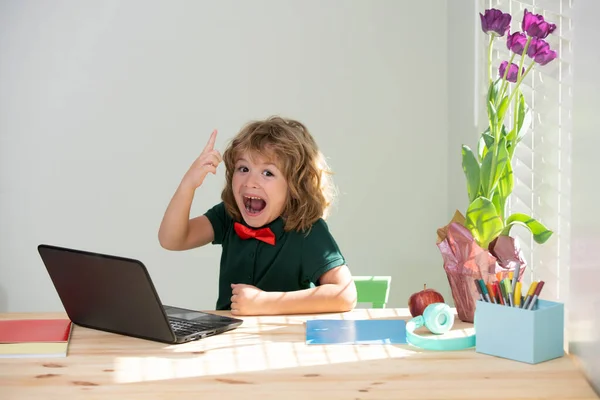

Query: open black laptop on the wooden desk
left=38, top=244, right=243, bottom=344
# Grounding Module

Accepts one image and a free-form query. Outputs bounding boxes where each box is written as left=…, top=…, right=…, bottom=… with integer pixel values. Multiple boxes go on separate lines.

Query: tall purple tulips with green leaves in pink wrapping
left=437, top=8, right=557, bottom=322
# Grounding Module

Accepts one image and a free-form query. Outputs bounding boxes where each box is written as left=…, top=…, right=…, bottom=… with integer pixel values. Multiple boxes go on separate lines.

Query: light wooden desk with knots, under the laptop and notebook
left=0, top=309, right=598, bottom=400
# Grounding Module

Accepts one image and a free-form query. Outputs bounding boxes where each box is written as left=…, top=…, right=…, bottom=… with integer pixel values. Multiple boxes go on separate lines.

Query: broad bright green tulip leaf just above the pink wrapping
left=465, top=197, right=504, bottom=249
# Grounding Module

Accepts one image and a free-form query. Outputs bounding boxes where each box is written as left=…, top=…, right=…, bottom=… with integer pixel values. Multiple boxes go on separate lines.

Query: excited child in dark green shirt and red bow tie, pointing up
left=158, top=117, right=356, bottom=315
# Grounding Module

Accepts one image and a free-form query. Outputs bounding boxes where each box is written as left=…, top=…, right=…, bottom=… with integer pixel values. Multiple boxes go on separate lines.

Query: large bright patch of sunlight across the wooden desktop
left=114, top=310, right=420, bottom=383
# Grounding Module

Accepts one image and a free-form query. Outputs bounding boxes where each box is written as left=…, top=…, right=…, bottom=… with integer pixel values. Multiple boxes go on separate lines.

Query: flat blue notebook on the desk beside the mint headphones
left=306, top=319, right=406, bottom=344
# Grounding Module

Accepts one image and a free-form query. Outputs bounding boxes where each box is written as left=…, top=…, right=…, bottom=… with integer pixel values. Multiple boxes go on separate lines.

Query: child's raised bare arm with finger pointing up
left=158, top=130, right=222, bottom=250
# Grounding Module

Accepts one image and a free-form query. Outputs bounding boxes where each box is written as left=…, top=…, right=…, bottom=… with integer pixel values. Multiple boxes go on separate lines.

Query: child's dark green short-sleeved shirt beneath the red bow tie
left=205, top=202, right=346, bottom=310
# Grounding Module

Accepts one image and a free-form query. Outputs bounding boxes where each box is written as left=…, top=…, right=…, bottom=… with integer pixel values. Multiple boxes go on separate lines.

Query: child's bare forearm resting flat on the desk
left=231, top=265, right=357, bottom=315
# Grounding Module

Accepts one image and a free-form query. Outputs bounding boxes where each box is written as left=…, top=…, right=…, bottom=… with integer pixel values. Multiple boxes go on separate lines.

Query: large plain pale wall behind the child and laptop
left=0, top=0, right=450, bottom=311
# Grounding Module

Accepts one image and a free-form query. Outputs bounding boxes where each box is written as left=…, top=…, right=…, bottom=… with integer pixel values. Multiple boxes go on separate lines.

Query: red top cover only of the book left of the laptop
left=0, top=319, right=72, bottom=343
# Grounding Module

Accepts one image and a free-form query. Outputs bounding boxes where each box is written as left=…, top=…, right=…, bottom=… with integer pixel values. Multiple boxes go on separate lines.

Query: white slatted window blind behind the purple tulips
left=476, top=0, right=573, bottom=302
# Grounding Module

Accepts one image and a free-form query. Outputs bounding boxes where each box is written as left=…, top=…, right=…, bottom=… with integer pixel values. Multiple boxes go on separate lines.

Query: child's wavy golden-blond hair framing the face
left=221, top=116, right=336, bottom=231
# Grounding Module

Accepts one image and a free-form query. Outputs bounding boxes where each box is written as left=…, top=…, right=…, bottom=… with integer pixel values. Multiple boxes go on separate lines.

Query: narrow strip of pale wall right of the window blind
left=569, top=1, right=600, bottom=393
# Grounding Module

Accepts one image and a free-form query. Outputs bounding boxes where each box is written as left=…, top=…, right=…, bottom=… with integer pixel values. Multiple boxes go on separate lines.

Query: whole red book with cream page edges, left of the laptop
left=0, top=319, right=73, bottom=358
